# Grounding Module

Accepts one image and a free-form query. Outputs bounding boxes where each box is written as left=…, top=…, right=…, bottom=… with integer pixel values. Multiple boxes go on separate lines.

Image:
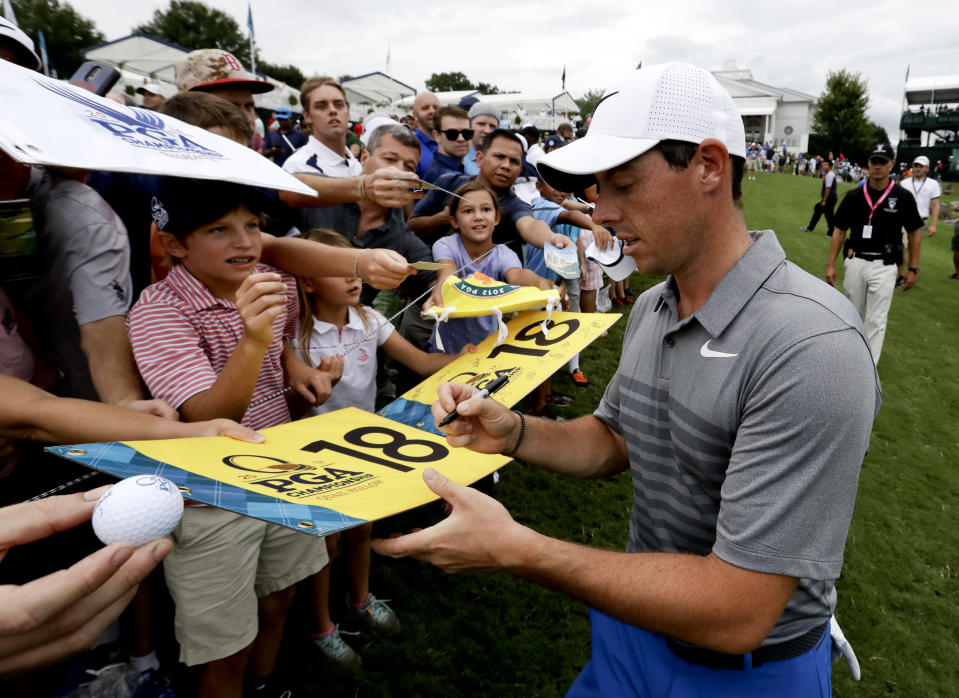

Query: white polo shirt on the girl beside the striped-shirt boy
left=294, top=306, right=394, bottom=416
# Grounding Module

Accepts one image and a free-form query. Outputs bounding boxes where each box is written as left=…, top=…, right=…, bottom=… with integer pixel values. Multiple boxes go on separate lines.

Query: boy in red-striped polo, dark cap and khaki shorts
left=127, top=177, right=331, bottom=696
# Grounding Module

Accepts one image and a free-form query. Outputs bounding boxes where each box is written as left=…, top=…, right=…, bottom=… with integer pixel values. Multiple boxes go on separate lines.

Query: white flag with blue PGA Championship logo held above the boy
left=0, top=61, right=316, bottom=195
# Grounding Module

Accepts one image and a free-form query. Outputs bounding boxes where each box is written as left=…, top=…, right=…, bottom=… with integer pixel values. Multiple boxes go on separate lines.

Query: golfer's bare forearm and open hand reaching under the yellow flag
left=372, top=468, right=798, bottom=654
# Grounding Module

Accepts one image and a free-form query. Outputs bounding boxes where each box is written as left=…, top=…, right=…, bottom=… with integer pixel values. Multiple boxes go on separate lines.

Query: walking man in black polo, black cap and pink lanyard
left=826, top=143, right=923, bottom=364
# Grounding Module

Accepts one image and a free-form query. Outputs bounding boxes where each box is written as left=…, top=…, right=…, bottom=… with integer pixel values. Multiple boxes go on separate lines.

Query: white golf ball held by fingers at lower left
left=93, top=475, right=183, bottom=546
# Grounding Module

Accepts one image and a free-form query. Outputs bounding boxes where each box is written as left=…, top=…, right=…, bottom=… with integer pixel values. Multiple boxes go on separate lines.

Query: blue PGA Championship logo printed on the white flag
left=35, top=80, right=223, bottom=160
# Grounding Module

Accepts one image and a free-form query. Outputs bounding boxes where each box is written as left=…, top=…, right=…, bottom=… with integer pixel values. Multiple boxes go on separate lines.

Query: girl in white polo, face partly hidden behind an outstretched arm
left=290, top=230, right=475, bottom=666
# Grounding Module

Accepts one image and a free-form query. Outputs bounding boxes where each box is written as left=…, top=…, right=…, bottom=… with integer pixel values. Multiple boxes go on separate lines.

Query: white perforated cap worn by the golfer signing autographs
left=536, top=63, right=746, bottom=191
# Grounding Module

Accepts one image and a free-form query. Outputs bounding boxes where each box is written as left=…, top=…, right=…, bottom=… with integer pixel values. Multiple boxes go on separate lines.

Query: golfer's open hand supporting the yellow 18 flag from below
left=371, top=468, right=528, bottom=572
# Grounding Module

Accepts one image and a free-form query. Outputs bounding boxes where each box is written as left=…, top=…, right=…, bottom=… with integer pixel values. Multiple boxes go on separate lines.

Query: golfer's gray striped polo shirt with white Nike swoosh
left=595, top=231, right=882, bottom=644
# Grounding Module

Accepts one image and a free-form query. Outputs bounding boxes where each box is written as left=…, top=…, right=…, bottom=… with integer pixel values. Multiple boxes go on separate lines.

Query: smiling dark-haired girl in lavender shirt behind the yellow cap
left=428, top=181, right=553, bottom=352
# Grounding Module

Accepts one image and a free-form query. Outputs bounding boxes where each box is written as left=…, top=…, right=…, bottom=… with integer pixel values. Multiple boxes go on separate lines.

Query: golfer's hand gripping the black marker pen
left=432, top=383, right=520, bottom=453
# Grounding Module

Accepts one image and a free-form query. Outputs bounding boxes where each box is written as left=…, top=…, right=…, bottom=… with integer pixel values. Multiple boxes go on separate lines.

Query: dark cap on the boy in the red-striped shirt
left=150, top=177, right=267, bottom=236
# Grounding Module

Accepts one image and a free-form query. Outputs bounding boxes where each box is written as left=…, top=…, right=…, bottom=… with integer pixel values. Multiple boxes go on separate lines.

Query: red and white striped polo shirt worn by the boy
left=127, top=264, right=299, bottom=429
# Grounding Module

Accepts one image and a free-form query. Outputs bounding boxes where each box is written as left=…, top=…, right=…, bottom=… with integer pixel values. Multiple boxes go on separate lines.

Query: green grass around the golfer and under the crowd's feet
left=283, top=174, right=959, bottom=697
